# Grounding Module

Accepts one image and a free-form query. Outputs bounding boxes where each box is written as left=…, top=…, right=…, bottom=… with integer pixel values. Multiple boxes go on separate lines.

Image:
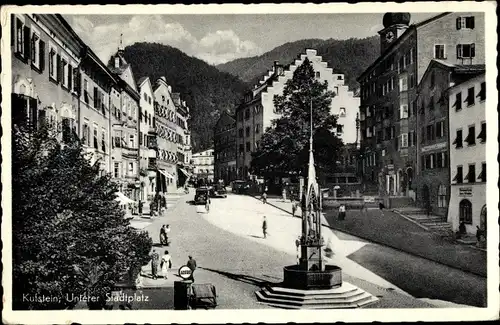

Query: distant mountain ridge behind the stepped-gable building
left=217, top=36, right=380, bottom=90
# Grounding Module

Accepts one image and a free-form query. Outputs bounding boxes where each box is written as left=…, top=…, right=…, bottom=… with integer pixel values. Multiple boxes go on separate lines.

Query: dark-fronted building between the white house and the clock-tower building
left=416, top=60, right=484, bottom=216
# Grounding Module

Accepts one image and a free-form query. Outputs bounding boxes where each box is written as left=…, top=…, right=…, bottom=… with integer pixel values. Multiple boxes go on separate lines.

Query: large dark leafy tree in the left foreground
left=12, top=120, right=152, bottom=309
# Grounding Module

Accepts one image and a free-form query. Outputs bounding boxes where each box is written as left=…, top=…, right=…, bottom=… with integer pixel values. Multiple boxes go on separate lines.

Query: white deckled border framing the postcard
left=1, top=1, right=500, bottom=324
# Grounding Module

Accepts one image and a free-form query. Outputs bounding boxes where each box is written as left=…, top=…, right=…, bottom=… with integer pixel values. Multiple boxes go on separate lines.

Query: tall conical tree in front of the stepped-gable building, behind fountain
left=252, top=58, right=342, bottom=180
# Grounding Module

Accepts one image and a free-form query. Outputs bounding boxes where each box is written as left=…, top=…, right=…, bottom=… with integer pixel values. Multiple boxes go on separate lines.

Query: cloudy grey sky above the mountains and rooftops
left=64, top=13, right=436, bottom=65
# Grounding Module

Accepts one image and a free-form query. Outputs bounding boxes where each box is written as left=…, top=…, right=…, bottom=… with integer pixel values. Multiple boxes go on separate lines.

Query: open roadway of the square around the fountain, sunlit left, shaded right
left=129, top=194, right=484, bottom=309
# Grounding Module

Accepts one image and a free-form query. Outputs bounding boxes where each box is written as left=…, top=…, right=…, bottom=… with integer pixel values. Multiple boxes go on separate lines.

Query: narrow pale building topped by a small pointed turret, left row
left=108, top=45, right=144, bottom=205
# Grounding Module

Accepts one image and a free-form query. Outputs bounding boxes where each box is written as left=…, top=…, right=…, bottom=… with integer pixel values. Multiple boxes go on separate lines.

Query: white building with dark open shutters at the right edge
left=448, top=70, right=486, bottom=233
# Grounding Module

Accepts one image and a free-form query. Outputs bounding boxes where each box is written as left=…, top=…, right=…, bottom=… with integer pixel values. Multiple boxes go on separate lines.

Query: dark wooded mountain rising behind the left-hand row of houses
left=119, top=43, right=248, bottom=152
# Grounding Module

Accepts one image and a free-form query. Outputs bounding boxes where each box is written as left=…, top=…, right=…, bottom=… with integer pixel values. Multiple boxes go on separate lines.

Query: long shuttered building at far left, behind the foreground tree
left=11, top=14, right=118, bottom=173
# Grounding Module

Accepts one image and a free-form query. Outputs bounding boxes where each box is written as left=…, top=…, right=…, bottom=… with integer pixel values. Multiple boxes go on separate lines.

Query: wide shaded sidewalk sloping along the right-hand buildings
left=255, top=197, right=487, bottom=277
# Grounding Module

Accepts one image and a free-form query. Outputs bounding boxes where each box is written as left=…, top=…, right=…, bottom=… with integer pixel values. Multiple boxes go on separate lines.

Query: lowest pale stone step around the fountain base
left=256, top=292, right=378, bottom=309
